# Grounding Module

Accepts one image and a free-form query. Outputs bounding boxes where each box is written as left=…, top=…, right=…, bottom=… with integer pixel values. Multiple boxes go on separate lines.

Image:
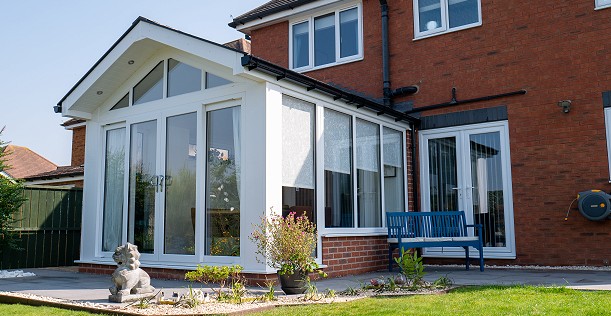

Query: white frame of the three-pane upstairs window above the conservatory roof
left=288, top=2, right=363, bottom=72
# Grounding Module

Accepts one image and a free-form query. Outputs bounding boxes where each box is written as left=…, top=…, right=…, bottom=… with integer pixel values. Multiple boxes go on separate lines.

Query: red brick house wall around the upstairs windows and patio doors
left=247, top=0, right=611, bottom=265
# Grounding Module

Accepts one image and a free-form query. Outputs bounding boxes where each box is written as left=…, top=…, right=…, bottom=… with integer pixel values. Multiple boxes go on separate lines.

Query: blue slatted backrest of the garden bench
left=386, top=211, right=468, bottom=238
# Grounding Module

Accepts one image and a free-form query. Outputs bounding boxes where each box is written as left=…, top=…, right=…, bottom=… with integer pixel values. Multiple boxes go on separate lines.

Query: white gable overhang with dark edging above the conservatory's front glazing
left=58, top=17, right=244, bottom=119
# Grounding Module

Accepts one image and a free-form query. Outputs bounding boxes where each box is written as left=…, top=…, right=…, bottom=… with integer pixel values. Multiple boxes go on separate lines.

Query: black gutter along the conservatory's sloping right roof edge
left=242, top=55, right=420, bottom=124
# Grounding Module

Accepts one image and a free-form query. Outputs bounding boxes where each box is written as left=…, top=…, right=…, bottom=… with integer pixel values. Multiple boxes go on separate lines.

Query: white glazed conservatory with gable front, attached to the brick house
left=58, top=18, right=410, bottom=273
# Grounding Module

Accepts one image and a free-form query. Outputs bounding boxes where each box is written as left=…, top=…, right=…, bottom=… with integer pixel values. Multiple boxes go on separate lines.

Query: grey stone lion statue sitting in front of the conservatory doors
left=110, top=243, right=155, bottom=296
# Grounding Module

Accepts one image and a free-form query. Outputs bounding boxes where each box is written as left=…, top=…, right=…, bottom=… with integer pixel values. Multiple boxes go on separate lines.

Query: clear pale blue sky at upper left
left=0, top=0, right=267, bottom=165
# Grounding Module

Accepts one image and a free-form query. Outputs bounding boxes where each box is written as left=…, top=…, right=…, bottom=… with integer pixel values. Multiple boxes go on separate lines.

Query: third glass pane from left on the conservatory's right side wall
left=355, top=119, right=382, bottom=227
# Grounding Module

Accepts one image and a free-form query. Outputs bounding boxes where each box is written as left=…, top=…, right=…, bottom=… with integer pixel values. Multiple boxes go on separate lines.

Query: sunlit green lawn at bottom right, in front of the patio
left=256, top=286, right=611, bottom=316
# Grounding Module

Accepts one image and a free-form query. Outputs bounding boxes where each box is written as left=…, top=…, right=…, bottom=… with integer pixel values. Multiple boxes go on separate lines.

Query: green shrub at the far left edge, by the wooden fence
left=0, top=127, right=25, bottom=253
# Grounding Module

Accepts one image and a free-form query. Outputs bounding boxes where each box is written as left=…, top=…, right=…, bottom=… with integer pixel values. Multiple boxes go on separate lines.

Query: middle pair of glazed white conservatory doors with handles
left=127, top=112, right=197, bottom=261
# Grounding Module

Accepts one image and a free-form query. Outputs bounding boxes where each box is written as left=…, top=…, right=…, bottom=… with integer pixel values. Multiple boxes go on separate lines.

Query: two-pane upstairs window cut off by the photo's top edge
left=414, top=0, right=482, bottom=38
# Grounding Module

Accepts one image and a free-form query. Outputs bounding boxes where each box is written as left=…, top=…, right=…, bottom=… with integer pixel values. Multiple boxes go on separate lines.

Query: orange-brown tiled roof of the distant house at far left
left=4, top=145, right=57, bottom=179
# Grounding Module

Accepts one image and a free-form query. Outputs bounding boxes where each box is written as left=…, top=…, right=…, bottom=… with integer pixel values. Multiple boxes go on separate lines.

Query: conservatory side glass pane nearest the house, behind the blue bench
left=383, top=127, right=405, bottom=212
